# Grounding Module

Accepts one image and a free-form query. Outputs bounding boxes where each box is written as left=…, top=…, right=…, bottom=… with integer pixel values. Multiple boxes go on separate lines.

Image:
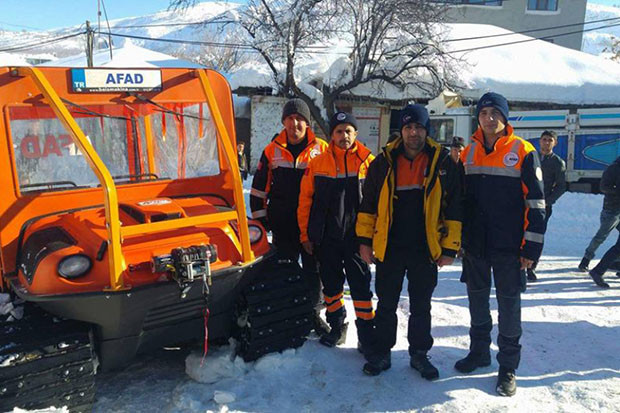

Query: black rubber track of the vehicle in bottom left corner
left=0, top=307, right=95, bottom=412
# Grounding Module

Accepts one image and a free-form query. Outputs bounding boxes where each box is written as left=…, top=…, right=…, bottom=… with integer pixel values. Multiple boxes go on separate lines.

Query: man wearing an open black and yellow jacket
left=356, top=105, right=462, bottom=380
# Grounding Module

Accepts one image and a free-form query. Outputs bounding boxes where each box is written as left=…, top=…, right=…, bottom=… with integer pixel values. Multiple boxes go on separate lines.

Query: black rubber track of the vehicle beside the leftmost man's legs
left=237, top=259, right=314, bottom=361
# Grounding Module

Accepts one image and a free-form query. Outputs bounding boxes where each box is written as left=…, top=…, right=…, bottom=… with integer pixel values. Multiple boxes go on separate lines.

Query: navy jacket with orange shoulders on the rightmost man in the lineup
left=461, top=125, right=545, bottom=261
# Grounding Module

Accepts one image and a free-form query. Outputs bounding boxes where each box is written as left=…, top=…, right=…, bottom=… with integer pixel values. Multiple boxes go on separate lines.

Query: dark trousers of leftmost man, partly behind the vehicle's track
left=272, top=227, right=323, bottom=311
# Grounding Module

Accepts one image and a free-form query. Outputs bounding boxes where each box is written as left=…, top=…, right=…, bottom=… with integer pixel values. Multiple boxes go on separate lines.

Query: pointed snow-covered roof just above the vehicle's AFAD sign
left=40, top=41, right=202, bottom=68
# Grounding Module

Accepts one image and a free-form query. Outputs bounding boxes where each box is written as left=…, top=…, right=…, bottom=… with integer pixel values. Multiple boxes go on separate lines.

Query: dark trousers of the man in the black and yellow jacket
left=375, top=246, right=437, bottom=354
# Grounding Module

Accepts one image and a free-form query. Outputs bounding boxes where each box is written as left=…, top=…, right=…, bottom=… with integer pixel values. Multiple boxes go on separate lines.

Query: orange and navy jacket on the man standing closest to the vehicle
left=250, top=129, right=327, bottom=231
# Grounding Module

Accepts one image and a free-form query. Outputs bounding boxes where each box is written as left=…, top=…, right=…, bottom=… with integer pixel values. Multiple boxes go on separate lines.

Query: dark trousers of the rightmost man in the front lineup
left=463, top=254, right=524, bottom=370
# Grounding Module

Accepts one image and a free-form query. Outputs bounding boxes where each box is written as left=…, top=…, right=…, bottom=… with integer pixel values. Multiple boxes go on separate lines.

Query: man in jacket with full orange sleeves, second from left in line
left=297, top=112, right=374, bottom=351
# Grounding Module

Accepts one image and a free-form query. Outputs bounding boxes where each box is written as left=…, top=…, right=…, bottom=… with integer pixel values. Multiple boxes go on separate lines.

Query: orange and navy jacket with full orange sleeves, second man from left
left=297, top=141, right=374, bottom=244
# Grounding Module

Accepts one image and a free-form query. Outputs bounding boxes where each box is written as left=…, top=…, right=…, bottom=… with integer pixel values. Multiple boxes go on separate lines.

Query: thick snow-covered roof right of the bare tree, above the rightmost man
left=449, top=24, right=620, bottom=105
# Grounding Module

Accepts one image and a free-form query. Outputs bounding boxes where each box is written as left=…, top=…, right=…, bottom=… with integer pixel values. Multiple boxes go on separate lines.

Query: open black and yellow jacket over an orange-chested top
left=355, top=138, right=463, bottom=262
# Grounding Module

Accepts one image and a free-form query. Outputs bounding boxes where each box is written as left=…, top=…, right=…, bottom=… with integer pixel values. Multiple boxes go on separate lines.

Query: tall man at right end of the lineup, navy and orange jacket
left=455, top=92, right=545, bottom=396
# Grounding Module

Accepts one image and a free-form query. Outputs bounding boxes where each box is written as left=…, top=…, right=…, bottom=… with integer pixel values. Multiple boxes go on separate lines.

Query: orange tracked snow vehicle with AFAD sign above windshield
left=0, top=67, right=311, bottom=410
